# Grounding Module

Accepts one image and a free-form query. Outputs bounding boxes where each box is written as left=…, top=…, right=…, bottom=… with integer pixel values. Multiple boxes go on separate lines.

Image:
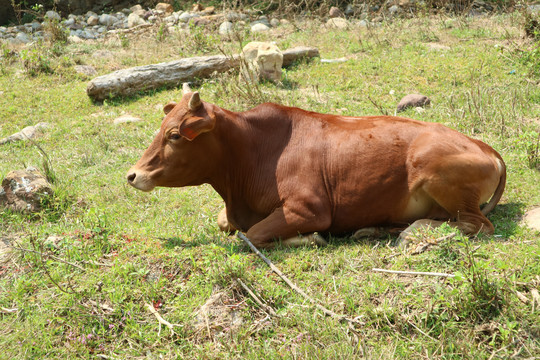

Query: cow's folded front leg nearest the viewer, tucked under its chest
left=246, top=207, right=331, bottom=248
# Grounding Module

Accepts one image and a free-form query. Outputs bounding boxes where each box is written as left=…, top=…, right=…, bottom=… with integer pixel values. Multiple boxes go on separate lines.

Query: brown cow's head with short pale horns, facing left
left=126, top=84, right=216, bottom=191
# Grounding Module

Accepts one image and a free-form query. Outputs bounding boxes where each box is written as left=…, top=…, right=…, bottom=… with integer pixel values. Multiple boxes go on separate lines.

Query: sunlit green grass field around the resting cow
left=0, top=9, right=540, bottom=359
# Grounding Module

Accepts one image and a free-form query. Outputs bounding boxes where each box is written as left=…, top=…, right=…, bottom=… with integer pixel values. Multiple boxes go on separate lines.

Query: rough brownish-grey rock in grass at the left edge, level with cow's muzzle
left=0, top=169, right=53, bottom=212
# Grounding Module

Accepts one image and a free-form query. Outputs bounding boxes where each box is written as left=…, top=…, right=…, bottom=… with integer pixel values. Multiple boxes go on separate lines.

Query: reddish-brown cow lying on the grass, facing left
left=127, top=85, right=506, bottom=248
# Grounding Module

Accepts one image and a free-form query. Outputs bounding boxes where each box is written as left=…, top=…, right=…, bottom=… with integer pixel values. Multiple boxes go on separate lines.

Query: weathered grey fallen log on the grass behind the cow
left=86, top=46, right=319, bottom=101
